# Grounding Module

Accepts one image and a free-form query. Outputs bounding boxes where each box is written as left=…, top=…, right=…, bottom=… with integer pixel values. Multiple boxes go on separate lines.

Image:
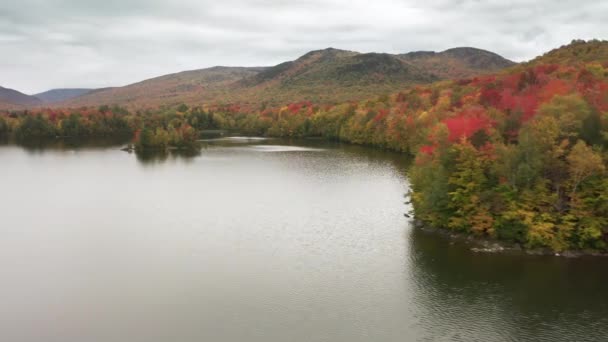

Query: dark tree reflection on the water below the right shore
left=409, top=229, right=608, bottom=341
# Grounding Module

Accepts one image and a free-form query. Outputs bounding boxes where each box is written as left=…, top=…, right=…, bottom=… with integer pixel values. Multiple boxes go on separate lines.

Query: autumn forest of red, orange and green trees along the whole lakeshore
left=0, top=41, right=608, bottom=251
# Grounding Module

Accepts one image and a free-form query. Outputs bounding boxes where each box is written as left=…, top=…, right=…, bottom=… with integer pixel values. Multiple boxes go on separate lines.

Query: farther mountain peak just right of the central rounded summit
left=399, top=47, right=516, bottom=79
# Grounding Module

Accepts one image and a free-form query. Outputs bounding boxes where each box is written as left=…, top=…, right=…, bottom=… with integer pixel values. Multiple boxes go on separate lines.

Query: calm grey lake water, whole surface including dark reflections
left=0, top=138, right=608, bottom=342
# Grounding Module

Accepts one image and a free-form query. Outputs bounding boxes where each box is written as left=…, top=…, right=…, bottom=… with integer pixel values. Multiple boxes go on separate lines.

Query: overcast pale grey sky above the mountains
left=0, top=0, right=608, bottom=94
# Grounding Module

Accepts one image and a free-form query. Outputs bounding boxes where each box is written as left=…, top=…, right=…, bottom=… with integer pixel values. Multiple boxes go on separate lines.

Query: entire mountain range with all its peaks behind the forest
left=56, top=48, right=515, bottom=108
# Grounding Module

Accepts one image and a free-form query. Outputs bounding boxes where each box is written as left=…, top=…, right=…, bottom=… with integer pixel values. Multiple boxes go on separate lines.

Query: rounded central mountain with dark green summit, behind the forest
left=235, top=48, right=439, bottom=103
